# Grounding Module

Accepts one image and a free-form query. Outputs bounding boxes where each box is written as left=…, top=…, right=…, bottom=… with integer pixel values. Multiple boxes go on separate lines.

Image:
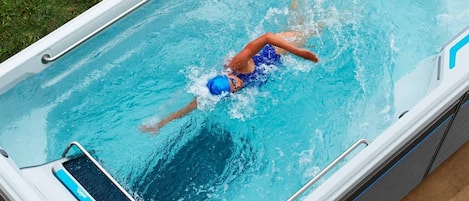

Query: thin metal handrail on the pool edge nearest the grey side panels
left=288, top=139, right=370, bottom=201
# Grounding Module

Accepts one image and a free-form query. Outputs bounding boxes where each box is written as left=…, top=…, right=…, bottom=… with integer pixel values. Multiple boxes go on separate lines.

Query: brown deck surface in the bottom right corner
left=403, top=142, right=469, bottom=201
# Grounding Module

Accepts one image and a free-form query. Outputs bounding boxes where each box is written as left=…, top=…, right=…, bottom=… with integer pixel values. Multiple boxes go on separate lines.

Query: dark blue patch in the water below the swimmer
left=133, top=120, right=255, bottom=200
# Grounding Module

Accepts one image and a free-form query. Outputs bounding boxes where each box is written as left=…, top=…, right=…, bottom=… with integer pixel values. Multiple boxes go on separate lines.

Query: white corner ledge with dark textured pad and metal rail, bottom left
left=16, top=142, right=135, bottom=201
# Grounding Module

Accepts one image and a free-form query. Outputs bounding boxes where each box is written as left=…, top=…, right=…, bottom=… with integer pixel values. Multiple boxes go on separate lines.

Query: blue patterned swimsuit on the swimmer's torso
left=237, top=44, right=282, bottom=86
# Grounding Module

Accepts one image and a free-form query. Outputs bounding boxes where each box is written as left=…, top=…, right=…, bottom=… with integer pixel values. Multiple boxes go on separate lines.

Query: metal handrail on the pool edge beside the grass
left=41, top=0, right=148, bottom=64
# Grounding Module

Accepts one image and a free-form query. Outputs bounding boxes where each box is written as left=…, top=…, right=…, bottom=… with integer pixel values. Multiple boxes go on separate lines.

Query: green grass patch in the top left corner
left=0, top=0, right=100, bottom=63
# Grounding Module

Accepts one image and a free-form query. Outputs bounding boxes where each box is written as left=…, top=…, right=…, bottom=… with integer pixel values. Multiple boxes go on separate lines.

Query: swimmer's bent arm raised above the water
left=228, top=33, right=319, bottom=71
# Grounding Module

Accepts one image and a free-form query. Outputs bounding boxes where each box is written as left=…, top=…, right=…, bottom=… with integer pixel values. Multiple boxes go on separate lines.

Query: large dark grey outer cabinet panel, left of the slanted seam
left=346, top=104, right=457, bottom=200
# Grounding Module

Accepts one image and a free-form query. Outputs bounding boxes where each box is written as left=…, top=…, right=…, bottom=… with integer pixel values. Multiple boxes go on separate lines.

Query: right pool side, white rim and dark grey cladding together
left=305, top=29, right=469, bottom=200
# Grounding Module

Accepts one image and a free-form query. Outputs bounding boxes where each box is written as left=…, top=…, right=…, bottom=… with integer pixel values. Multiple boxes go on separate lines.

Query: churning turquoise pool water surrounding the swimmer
left=0, top=0, right=469, bottom=200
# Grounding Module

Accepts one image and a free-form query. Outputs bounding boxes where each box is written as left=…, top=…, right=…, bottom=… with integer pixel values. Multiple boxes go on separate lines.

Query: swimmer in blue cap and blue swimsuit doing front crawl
left=140, top=1, right=319, bottom=133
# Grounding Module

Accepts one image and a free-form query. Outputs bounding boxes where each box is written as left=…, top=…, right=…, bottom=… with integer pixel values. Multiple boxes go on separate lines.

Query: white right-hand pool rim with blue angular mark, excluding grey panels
left=306, top=25, right=469, bottom=200
